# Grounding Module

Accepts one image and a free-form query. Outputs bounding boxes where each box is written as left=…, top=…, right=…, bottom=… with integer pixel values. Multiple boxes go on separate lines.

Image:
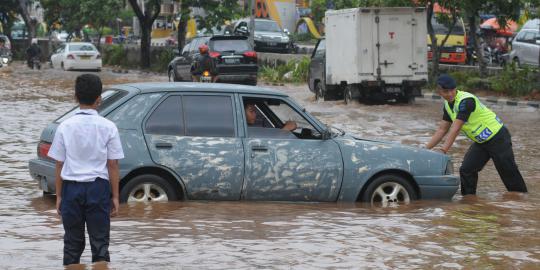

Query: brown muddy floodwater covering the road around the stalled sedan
left=0, top=63, right=540, bottom=269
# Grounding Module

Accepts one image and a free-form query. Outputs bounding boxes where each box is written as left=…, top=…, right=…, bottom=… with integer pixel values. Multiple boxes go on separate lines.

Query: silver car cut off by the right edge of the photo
left=509, top=19, right=540, bottom=66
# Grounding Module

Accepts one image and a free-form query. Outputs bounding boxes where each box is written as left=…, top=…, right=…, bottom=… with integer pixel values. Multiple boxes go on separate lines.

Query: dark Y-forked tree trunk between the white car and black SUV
left=129, top=0, right=161, bottom=68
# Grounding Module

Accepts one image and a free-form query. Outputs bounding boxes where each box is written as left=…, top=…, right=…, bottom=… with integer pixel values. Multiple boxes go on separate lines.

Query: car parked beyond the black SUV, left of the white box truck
left=233, top=19, right=297, bottom=53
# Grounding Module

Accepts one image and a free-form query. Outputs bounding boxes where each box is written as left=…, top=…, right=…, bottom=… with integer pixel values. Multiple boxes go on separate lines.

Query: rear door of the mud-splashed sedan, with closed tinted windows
left=143, top=93, right=244, bottom=200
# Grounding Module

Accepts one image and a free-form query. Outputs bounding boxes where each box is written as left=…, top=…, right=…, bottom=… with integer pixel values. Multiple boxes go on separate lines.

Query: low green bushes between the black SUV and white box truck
left=259, top=56, right=311, bottom=83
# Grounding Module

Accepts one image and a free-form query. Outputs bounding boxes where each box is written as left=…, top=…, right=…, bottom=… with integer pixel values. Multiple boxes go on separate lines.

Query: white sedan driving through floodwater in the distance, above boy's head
left=51, top=42, right=102, bottom=71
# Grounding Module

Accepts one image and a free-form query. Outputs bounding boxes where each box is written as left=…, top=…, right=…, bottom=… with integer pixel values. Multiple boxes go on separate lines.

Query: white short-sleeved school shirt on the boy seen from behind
left=47, top=109, right=124, bottom=182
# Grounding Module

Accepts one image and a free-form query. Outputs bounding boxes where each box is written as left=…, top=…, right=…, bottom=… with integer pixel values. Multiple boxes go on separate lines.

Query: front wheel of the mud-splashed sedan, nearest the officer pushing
left=362, top=174, right=418, bottom=207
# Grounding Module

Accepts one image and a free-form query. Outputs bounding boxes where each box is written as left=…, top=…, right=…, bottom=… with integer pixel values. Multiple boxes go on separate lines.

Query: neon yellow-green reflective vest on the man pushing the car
left=444, top=90, right=503, bottom=143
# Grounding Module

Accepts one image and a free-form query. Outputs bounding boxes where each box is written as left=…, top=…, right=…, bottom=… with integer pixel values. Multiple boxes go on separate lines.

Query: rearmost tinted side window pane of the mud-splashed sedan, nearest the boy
left=145, top=96, right=184, bottom=136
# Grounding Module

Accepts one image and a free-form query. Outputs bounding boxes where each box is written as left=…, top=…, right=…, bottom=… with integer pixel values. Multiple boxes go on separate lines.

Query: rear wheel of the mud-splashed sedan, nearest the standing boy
left=120, top=174, right=178, bottom=202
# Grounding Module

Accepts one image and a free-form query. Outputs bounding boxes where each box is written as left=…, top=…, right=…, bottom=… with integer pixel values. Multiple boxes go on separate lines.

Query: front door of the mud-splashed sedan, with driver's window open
left=242, top=96, right=343, bottom=201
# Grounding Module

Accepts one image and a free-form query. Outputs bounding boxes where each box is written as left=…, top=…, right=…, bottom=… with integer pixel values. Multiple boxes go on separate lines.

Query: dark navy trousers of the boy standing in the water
left=60, top=177, right=111, bottom=265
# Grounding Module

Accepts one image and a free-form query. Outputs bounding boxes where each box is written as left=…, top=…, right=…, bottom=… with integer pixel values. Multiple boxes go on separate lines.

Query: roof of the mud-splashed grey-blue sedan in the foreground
left=111, top=82, right=288, bottom=97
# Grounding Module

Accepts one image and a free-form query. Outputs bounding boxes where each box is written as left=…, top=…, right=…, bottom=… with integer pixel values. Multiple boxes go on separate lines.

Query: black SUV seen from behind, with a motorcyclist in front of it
left=167, top=36, right=258, bottom=85
